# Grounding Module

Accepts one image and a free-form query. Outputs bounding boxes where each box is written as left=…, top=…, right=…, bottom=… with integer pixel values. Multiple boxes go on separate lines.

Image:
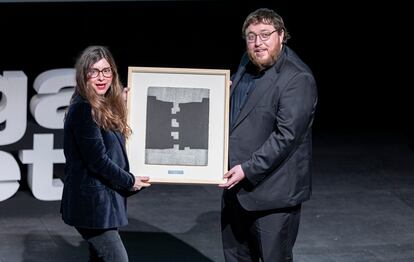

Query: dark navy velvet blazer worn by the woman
left=61, top=96, right=135, bottom=228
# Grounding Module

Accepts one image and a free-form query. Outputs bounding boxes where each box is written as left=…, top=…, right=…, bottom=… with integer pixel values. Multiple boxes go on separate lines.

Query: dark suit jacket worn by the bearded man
left=229, top=46, right=317, bottom=211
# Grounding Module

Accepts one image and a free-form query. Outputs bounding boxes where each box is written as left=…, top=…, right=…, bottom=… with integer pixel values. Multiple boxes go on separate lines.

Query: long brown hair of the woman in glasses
left=74, top=46, right=132, bottom=138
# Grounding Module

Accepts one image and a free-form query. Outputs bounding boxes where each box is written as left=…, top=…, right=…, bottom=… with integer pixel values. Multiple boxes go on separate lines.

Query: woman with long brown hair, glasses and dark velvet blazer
left=61, top=46, right=150, bottom=261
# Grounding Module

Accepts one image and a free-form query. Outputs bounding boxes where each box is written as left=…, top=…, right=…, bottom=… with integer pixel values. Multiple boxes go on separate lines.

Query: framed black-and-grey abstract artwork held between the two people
left=126, top=67, right=230, bottom=184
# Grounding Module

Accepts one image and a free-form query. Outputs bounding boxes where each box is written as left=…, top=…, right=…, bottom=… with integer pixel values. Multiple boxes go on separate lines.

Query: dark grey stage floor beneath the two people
left=0, top=133, right=414, bottom=262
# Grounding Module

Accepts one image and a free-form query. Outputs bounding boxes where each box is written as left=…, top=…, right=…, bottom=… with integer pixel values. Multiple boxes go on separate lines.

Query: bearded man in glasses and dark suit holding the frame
left=219, top=8, right=317, bottom=262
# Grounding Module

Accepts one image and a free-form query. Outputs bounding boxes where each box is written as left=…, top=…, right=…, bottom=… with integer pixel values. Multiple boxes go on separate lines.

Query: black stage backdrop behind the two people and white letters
left=0, top=1, right=413, bottom=192
